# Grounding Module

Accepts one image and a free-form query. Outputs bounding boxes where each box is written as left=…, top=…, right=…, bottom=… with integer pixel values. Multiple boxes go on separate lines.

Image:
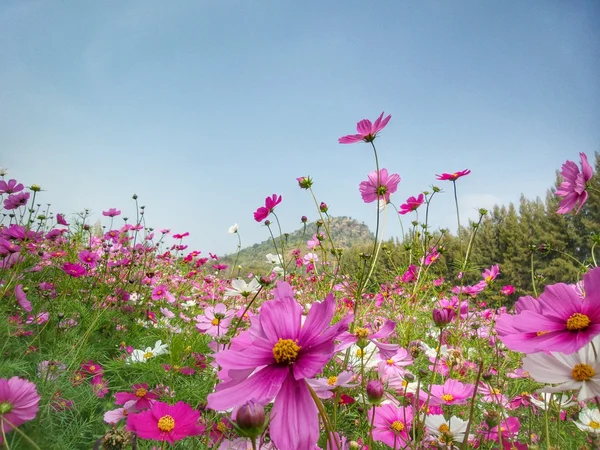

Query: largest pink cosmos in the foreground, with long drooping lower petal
left=208, top=282, right=350, bottom=450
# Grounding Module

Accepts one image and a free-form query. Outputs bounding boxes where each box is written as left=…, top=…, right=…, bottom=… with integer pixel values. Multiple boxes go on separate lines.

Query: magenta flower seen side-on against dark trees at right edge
left=555, top=153, right=594, bottom=214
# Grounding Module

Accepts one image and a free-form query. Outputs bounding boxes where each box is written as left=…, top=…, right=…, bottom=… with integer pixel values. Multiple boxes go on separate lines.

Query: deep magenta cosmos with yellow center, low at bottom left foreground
left=127, top=402, right=205, bottom=444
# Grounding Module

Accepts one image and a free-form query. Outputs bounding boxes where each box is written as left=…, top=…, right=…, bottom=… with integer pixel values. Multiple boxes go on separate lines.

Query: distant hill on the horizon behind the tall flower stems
left=220, top=216, right=374, bottom=273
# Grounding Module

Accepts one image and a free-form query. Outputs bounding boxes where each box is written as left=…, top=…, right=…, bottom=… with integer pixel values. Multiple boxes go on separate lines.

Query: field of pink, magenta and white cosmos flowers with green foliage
left=0, top=113, right=600, bottom=450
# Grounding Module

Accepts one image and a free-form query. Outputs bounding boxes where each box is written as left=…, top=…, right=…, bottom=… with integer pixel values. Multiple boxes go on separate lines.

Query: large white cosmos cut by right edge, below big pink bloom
left=523, top=336, right=600, bottom=402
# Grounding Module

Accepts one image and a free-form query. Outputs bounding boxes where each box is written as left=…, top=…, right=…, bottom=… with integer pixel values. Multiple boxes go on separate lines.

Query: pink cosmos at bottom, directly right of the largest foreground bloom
left=369, top=404, right=413, bottom=449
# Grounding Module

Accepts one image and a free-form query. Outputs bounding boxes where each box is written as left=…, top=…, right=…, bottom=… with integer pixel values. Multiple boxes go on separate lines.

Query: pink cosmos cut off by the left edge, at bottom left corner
left=0, top=377, right=40, bottom=436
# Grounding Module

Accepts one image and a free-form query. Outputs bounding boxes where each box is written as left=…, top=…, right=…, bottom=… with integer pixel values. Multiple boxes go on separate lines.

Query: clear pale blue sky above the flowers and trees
left=0, top=0, right=600, bottom=254
